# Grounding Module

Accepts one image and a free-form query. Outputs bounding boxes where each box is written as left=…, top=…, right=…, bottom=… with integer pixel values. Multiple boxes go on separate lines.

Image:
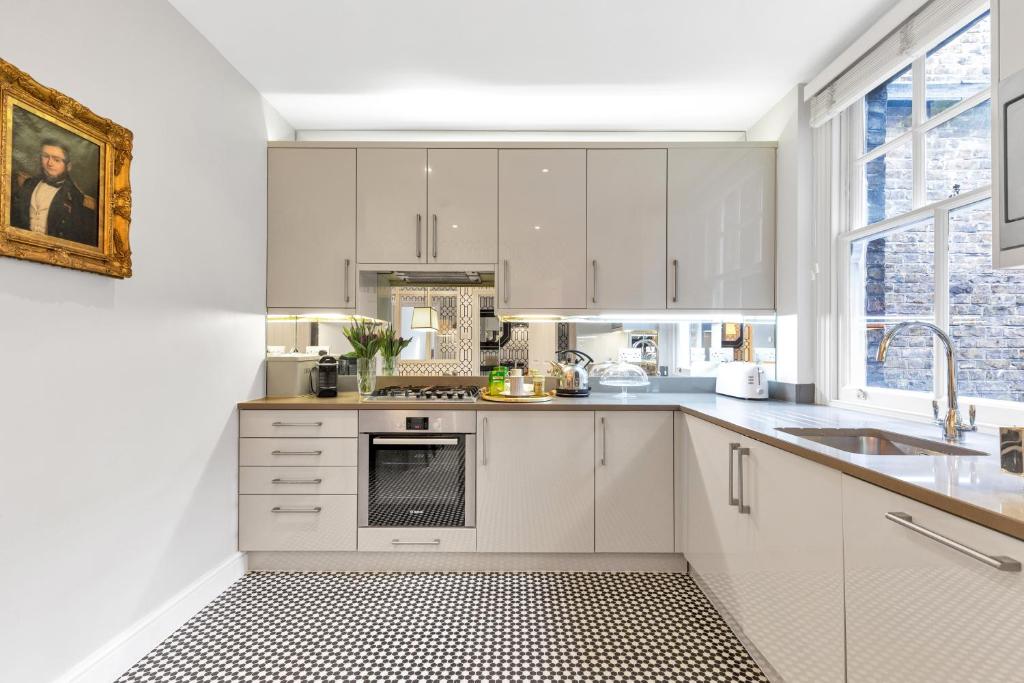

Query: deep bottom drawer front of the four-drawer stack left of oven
left=239, top=496, right=356, bottom=550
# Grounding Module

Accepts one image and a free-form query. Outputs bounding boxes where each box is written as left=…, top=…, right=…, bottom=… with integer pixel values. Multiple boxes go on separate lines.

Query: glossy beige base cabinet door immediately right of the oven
left=476, top=411, right=594, bottom=553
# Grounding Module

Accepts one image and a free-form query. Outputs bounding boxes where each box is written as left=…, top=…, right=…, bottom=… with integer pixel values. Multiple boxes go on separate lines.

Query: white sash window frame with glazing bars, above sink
left=831, top=7, right=1024, bottom=427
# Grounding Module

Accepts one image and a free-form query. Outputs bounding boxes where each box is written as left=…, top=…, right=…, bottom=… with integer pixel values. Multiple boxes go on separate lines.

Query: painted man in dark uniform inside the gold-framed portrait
left=10, top=138, right=99, bottom=247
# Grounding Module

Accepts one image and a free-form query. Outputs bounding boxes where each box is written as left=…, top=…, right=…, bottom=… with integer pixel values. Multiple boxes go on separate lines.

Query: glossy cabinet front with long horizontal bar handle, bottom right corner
left=843, top=476, right=1024, bottom=683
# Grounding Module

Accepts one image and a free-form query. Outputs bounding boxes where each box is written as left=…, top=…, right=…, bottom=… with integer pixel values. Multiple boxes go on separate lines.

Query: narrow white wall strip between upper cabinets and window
left=746, top=85, right=814, bottom=384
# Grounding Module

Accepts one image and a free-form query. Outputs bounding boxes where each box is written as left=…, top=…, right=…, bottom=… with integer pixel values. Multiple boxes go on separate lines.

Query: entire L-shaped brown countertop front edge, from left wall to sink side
left=238, top=396, right=1024, bottom=541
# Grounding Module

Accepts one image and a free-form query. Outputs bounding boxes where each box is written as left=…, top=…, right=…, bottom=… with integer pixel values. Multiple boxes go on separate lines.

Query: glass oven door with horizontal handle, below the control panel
left=358, top=433, right=476, bottom=527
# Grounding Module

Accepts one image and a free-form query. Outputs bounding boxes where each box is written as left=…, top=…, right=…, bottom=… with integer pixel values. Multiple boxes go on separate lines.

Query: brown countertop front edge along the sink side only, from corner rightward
left=679, top=407, right=1024, bottom=541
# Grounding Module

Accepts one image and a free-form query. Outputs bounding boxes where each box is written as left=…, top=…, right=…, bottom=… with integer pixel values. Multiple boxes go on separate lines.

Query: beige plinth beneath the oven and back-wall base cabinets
left=248, top=551, right=686, bottom=572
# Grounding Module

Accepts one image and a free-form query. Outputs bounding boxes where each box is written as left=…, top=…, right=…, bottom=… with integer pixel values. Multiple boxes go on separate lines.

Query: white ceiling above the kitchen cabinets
left=170, top=0, right=896, bottom=131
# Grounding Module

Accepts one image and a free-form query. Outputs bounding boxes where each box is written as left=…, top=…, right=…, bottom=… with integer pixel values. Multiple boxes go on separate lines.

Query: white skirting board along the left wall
left=57, top=553, right=246, bottom=683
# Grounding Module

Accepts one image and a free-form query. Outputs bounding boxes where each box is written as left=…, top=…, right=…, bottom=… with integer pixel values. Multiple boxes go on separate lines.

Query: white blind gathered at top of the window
left=811, top=0, right=988, bottom=127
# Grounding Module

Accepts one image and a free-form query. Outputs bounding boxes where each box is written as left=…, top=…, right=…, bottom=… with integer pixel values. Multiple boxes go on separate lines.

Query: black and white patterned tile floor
left=118, top=572, right=766, bottom=683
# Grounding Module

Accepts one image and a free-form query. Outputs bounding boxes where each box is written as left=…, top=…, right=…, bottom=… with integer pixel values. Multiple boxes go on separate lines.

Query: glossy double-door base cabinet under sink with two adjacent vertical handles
left=686, top=418, right=844, bottom=682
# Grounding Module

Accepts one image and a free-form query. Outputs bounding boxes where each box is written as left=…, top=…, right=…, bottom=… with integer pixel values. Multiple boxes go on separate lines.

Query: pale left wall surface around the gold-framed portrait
left=0, top=0, right=266, bottom=683
